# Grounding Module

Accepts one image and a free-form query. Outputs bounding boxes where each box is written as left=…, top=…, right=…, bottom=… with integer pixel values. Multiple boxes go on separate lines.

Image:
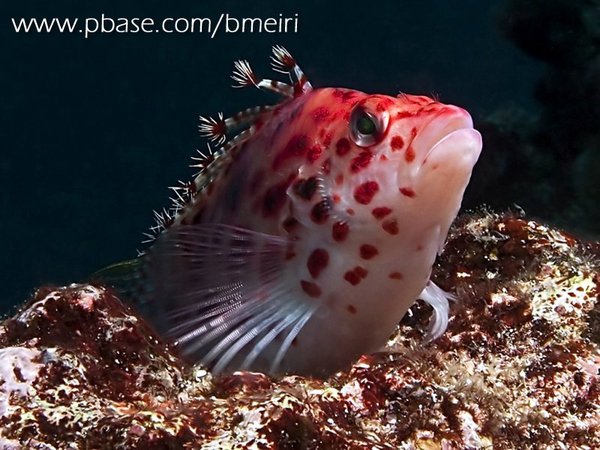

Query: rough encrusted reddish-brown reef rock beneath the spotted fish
left=0, top=212, right=600, bottom=449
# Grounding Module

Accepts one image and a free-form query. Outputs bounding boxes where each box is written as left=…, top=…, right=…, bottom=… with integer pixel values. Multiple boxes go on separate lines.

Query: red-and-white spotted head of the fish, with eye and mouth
left=291, top=89, right=482, bottom=250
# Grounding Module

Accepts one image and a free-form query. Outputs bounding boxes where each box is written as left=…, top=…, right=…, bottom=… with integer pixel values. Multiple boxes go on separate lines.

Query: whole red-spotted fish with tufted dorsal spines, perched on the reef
left=103, top=46, right=482, bottom=377
